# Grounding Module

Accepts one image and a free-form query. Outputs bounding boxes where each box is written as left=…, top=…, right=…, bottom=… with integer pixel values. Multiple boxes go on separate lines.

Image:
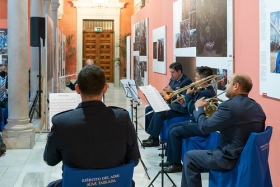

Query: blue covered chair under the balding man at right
left=209, top=126, right=272, bottom=187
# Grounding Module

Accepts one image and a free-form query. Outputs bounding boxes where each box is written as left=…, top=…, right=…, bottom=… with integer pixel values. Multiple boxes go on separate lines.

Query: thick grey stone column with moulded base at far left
left=2, top=0, right=35, bottom=149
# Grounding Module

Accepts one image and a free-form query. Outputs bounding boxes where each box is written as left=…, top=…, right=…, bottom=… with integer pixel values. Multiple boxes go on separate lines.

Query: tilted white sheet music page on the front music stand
left=139, top=85, right=170, bottom=112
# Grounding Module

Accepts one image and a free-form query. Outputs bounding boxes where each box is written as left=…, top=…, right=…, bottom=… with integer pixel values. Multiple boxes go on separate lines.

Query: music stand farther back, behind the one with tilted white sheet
left=121, top=79, right=150, bottom=180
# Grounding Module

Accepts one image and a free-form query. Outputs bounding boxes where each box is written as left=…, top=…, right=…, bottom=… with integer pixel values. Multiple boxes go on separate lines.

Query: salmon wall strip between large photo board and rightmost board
left=234, top=0, right=280, bottom=187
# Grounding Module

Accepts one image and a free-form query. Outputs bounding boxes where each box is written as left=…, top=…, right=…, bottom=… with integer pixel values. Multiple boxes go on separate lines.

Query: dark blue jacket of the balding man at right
left=194, top=94, right=266, bottom=169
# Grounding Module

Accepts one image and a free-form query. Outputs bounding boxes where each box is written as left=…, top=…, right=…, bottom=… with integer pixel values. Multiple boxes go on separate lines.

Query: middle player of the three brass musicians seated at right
left=163, top=66, right=216, bottom=173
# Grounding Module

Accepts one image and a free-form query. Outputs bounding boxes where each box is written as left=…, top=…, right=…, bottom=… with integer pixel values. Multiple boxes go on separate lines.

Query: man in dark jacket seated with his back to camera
left=44, top=66, right=140, bottom=187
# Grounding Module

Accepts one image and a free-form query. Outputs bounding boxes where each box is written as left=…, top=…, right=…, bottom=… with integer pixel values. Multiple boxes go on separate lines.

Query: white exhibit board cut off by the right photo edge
left=259, top=0, right=280, bottom=99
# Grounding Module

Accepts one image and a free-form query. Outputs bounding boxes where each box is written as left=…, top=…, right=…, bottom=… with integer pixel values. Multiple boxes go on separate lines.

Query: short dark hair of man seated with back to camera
left=77, top=66, right=106, bottom=95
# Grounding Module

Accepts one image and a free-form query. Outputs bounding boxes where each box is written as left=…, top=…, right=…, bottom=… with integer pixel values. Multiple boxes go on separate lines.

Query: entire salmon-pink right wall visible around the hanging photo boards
left=131, top=0, right=280, bottom=187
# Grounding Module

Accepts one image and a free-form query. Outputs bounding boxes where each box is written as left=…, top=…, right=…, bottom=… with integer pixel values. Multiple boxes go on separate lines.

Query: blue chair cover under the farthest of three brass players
left=159, top=114, right=190, bottom=142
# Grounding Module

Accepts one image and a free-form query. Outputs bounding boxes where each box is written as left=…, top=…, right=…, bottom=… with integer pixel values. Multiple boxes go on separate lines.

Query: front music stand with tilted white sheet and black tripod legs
left=139, top=85, right=176, bottom=187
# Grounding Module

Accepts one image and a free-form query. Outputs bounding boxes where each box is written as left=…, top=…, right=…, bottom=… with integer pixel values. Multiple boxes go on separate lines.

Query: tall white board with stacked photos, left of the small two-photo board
left=131, top=18, right=149, bottom=86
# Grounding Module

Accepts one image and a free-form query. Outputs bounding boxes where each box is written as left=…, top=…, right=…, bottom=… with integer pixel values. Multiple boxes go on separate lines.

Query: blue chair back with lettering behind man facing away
left=62, top=160, right=135, bottom=187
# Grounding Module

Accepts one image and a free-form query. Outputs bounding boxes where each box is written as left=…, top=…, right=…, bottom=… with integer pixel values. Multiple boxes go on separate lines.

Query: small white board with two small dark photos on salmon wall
left=153, top=26, right=166, bottom=74
